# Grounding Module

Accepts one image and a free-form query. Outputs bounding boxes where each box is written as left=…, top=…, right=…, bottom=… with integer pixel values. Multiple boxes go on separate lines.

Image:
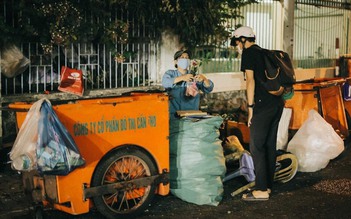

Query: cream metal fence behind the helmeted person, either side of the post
left=198, top=0, right=351, bottom=73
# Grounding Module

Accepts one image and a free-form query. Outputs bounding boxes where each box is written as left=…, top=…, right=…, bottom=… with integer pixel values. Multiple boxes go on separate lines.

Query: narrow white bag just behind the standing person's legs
left=277, top=108, right=292, bottom=151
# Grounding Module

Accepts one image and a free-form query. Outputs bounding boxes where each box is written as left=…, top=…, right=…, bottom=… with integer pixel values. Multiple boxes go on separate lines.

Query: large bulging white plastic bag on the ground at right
left=288, top=109, right=344, bottom=172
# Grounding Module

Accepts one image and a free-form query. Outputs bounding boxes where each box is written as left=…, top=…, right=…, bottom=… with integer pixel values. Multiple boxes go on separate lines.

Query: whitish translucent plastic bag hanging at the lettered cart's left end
left=10, top=99, right=46, bottom=171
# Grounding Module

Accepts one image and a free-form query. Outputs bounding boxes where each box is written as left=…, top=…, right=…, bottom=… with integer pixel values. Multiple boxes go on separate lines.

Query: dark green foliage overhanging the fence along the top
left=0, top=0, right=257, bottom=52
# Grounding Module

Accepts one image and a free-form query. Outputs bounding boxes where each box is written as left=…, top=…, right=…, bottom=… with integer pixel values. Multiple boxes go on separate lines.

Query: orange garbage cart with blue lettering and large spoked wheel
left=9, top=92, right=169, bottom=218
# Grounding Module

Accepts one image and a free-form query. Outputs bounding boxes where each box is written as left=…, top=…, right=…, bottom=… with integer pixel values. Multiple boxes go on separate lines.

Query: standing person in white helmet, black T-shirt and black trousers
left=231, top=27, right=284, bottom=201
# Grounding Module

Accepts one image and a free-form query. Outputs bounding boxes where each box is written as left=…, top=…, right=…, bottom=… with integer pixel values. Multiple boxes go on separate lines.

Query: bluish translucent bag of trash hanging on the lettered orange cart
left=36, top=101, right=85, bottom=175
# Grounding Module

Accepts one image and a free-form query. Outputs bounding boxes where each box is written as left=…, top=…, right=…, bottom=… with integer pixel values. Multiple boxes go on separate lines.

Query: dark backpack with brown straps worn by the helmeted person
left=261, top=49, right=296, bottom=99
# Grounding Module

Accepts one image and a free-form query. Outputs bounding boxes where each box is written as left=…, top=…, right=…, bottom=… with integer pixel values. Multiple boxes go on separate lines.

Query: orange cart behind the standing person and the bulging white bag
left=225, top=78, right=351, bottom=144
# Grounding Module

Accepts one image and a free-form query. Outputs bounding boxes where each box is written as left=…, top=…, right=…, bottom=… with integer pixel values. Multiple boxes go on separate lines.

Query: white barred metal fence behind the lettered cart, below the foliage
left=1, top=43, right=158, bottom=95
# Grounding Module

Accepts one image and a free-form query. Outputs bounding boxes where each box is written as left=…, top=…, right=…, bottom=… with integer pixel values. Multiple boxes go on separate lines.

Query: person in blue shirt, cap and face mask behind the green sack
left=162, top=50, right=214, bottom=119
